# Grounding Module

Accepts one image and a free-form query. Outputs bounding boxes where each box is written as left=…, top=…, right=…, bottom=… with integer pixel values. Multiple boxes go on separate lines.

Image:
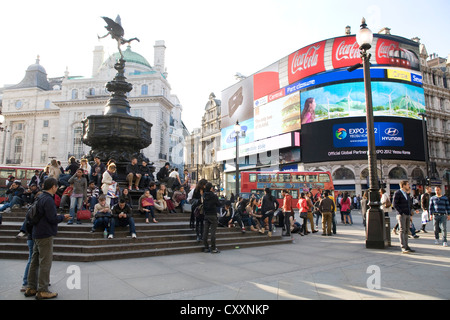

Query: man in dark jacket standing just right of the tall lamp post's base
left=393, top=180, right=414, bottom=253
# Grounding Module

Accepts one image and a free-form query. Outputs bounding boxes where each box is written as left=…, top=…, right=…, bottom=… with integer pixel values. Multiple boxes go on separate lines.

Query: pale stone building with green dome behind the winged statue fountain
left=0, top=41, right=187, bottom=170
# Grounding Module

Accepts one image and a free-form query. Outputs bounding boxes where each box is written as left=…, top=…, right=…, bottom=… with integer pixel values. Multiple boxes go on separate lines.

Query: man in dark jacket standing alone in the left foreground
left=25, top=178, right=70, bottom=299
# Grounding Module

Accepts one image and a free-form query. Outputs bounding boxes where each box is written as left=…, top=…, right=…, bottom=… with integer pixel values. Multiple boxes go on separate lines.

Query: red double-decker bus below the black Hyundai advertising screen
left=241, top=171, right=334, bottom=208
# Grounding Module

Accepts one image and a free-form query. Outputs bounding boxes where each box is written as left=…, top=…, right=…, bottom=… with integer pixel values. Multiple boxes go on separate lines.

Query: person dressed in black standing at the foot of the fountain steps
left=203, top=182, right=221, bottom=253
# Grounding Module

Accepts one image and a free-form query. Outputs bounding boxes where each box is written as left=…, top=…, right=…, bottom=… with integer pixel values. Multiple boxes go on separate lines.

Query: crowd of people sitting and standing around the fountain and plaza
left=0, top=158, right=450, bottom=299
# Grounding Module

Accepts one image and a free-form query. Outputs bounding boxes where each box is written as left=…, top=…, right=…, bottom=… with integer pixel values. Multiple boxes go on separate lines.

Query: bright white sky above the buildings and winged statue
left=0, top=0, right=450, bottom=131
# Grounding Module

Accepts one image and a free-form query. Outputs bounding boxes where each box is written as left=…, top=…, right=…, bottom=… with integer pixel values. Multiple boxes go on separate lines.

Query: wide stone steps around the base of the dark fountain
left=0, top=209, right=291, bottom=262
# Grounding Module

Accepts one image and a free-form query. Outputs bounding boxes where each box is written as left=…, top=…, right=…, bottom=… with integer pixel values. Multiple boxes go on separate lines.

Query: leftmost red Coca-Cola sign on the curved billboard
left=288, top=41, right=326, bottom=83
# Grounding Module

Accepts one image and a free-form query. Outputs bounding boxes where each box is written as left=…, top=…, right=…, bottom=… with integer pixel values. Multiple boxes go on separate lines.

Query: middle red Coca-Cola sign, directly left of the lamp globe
left=331, top=36, right=361, bottom=69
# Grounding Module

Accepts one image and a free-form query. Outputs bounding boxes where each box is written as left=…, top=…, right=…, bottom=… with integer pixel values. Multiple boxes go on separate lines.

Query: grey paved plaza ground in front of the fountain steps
left=0, top=210, right=450, bottom=301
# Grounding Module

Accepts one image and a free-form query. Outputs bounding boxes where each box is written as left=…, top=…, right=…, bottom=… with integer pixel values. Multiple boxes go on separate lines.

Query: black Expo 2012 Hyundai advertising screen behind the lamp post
left=302, top=117, right=425, bottom=163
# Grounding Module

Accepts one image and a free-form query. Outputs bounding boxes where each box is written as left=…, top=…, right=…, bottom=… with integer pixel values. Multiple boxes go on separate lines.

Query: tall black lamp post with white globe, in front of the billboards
left=356, top=18, right=386, bottom=249
